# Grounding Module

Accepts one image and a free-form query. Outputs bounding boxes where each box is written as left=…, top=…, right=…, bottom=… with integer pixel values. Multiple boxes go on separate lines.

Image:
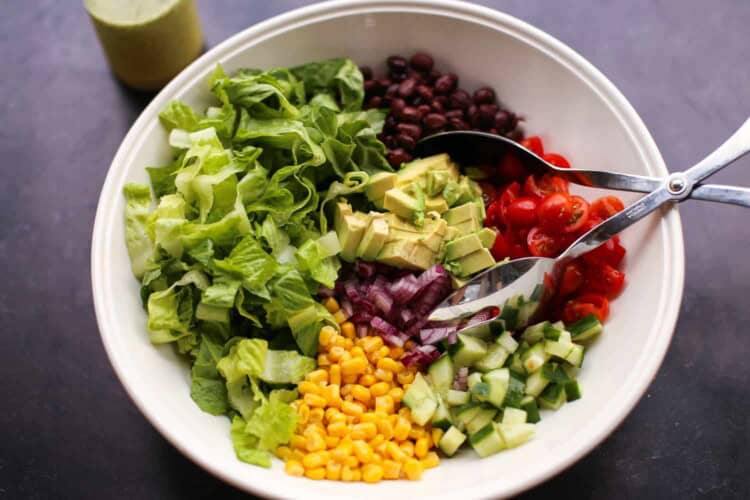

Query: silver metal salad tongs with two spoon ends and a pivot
left=419, top=115, right=750, bottom=331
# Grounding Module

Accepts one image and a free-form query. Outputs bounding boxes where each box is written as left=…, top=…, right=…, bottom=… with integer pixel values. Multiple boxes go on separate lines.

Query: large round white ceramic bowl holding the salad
left=91, top=0, right=684, bottom=500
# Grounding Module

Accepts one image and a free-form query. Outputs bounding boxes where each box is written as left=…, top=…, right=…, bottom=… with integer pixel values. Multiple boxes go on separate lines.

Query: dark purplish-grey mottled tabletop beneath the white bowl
left=0, top=0, right=750, bottom=500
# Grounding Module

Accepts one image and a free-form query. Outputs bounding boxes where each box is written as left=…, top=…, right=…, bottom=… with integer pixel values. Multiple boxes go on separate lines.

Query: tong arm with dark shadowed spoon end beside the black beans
left=415, top=130, right=750, bottom=207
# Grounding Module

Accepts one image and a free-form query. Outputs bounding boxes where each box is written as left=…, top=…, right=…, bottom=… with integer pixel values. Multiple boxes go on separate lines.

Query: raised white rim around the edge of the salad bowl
left=91, top=0, right=685, bottom=498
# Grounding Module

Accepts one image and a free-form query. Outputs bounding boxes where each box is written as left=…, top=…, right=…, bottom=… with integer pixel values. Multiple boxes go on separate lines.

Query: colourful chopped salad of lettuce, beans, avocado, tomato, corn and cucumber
left=124, top=53, right=625, bottom=483
